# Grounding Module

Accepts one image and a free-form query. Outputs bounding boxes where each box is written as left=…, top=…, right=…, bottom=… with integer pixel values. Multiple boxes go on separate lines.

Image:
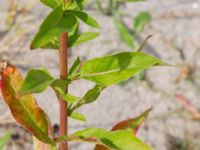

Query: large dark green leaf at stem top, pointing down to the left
left=31, top=5, right=77, bottom=49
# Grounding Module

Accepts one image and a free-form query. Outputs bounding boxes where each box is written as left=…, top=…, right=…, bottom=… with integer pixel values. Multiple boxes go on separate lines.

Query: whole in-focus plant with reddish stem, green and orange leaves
left=1, top=0, right=166, bottom=150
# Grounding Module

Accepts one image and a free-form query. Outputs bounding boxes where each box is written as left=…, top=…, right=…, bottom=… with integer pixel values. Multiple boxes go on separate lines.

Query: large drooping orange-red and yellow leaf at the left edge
left=1, top=65, right=54, bottom=144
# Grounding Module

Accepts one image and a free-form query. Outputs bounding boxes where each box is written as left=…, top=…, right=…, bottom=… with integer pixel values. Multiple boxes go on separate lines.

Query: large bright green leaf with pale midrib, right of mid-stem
left=80, top=52, right=167, bottom=86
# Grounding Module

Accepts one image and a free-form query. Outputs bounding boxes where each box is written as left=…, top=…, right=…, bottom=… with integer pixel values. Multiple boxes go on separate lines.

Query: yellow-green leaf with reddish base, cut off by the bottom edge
left=56, top=128, right=151, bottom=150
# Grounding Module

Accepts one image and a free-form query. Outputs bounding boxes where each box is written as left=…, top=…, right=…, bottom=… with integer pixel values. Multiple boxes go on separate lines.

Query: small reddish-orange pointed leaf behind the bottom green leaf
left=94, top=108, right=152, bottom=150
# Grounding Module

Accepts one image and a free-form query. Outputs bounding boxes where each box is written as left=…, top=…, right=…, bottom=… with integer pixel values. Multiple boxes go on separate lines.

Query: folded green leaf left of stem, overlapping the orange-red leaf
left=18, top=69, right=54, bottom=96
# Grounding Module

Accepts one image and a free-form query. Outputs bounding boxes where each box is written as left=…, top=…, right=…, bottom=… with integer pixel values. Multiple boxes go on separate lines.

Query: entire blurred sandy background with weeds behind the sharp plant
left=0, top=0, right=200, bottom=150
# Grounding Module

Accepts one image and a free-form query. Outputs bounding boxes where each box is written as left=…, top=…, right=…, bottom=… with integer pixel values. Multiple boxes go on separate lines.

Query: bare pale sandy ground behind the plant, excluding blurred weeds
left=0, top=0, right=200, bottom=150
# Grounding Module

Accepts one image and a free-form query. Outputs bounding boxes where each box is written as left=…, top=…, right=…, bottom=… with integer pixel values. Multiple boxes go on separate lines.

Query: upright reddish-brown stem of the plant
left=59, top=33, right=68, bottom=150
